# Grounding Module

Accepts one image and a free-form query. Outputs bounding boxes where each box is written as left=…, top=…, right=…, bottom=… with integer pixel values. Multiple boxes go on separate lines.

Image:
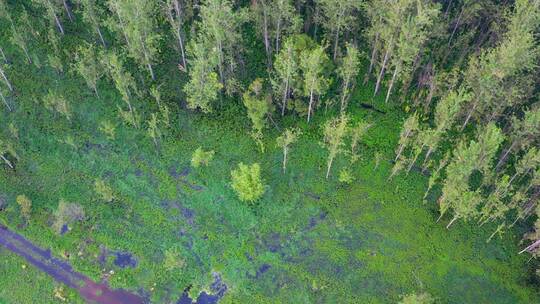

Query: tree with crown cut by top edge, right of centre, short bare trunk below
left=316, top=0, right=362, bottom=60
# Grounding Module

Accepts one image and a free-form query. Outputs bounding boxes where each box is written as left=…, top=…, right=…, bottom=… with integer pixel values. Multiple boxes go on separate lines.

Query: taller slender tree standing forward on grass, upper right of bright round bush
left=324, top=114, right=349, bottom=179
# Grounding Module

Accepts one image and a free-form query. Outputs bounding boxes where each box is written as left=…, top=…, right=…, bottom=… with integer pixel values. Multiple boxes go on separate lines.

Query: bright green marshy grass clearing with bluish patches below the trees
left=0, top=10, right=539, bottom=303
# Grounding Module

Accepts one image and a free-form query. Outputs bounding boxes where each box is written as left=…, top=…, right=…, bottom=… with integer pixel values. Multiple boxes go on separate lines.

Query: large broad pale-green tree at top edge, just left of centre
left=198, top=0, right=242, bottom=91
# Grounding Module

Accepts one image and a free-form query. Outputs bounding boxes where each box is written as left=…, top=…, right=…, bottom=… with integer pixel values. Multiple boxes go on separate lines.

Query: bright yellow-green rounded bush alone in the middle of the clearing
left=231, top=163, right=265, bottom=202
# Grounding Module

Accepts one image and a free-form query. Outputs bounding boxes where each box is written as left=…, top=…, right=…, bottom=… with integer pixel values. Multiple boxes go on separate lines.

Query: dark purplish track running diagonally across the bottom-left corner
left=0, top=224, right=144, bottom=304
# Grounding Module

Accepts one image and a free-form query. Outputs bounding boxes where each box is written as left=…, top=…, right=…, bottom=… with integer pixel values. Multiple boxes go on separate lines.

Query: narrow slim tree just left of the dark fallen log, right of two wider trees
left=337, top=44, right=360, bottom=112
